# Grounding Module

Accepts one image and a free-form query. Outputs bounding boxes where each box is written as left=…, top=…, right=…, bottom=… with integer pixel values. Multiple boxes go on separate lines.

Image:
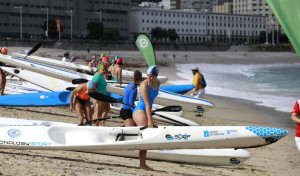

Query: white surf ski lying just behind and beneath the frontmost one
left=0, top=117, right=252, bottom=166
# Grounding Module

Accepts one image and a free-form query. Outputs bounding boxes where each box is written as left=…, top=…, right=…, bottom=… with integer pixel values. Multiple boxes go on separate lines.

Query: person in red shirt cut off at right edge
left=291, top=99, right=300, bottom=157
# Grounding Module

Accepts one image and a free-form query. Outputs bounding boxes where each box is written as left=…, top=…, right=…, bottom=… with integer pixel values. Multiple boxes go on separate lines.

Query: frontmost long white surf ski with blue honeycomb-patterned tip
left=0, top=125, right=288, bottom=151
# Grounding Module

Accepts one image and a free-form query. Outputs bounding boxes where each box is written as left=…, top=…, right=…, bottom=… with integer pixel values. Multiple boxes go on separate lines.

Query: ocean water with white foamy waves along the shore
left=169, top=63, right=300, bottom=112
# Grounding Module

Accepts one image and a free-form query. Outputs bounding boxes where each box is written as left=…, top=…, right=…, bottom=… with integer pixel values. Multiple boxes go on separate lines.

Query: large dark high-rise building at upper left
left=0, top=0, right=131, bottom=38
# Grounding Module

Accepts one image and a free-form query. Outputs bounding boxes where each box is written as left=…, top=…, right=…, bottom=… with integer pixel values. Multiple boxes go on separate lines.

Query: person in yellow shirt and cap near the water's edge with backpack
left=192, top=67, right=205, bottom=99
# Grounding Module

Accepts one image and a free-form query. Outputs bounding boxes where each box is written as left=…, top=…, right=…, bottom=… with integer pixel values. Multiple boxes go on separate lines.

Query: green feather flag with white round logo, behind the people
left=135, top=34, right=156, bottom=67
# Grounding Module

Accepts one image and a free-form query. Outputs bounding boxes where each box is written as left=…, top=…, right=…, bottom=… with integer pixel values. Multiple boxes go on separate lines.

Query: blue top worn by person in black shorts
left=122, top=82, right=137, bottom=111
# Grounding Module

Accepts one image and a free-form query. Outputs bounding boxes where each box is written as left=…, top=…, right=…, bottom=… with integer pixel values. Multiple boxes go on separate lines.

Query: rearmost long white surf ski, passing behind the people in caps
left=13, top=53, right=168, bottom=83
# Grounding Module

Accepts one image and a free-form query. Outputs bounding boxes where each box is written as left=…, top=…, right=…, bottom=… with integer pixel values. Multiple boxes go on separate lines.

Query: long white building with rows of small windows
left=129, top=8, right=265, bottom=43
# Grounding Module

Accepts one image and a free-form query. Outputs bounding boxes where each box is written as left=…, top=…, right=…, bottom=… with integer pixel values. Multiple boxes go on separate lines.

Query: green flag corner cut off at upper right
left=266, top=0, right=300, bottom=58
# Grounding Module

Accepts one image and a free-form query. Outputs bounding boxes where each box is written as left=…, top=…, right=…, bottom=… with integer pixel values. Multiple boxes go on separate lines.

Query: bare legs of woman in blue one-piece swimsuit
left=132, top=110, right=153, bottom=170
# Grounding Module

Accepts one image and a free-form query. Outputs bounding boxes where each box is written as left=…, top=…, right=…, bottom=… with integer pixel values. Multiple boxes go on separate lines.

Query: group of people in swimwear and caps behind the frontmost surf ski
left=70, top=52, right=160, bottom=170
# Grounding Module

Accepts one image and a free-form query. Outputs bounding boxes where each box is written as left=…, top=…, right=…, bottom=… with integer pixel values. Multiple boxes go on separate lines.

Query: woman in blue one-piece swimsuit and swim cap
left=132, top=65, right=160, bottom=170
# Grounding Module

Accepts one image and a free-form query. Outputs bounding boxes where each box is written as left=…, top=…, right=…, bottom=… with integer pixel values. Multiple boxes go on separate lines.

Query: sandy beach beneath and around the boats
left=0, top=47, right=300, bottom=176
